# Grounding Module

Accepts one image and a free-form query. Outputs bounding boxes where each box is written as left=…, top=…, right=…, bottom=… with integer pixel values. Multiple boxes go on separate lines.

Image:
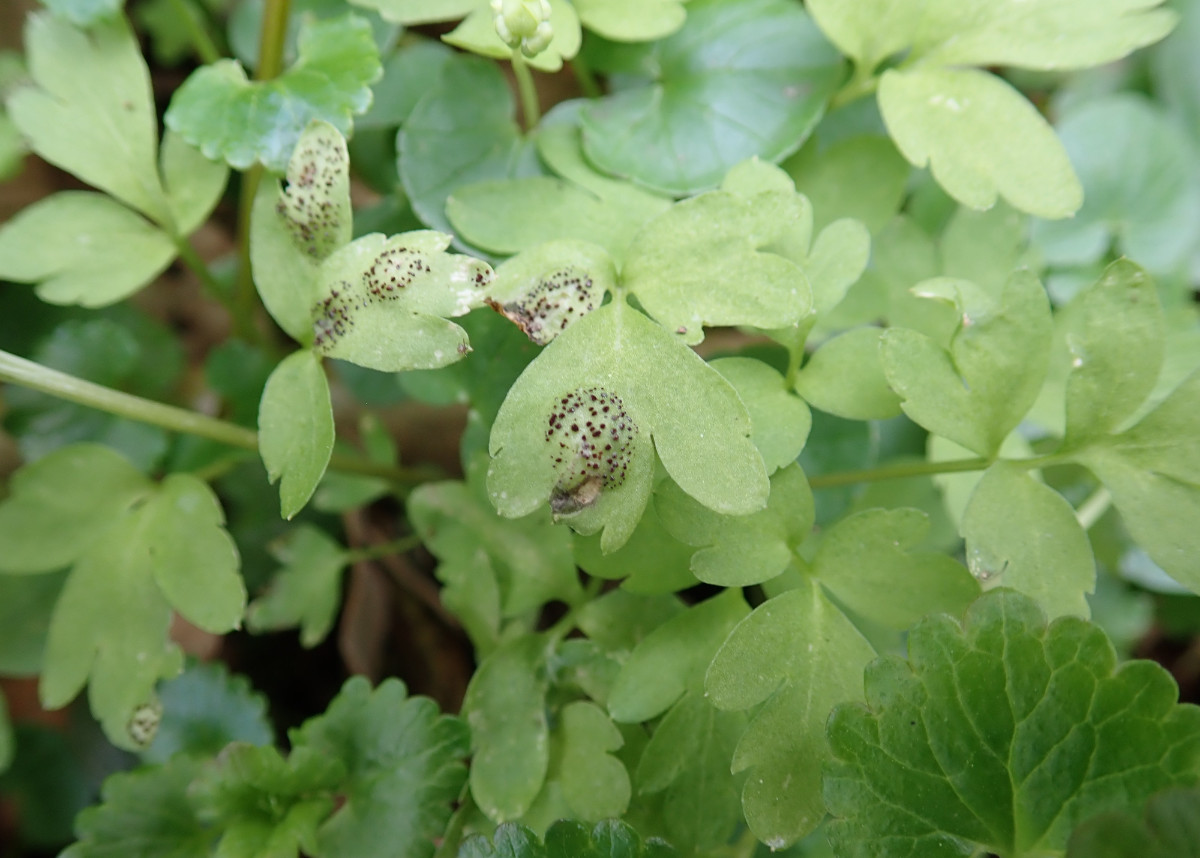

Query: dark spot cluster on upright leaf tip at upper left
left=275, top=139, right=346, bottom=259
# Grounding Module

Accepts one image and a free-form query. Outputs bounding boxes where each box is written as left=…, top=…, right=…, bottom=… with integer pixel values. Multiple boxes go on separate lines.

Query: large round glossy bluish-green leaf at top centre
left=581, top=0, right=842, bottom=196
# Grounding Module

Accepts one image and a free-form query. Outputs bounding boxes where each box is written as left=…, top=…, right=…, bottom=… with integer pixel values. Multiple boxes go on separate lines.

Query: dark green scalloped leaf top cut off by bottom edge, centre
left=458, top=820, right=674, bottom=858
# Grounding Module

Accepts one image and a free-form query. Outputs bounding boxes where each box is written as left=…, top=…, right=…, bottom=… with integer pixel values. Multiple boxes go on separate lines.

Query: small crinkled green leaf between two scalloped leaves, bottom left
left=187, top=742, right=346, bottom=858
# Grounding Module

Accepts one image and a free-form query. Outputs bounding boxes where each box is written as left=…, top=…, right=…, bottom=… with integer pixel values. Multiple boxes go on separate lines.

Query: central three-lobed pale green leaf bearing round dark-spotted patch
left=487, top=300, right=768, bottom=551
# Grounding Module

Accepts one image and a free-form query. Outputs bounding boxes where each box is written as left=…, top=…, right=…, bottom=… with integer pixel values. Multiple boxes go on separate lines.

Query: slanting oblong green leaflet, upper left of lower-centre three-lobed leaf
left=608, top=589, right=750, bottom=724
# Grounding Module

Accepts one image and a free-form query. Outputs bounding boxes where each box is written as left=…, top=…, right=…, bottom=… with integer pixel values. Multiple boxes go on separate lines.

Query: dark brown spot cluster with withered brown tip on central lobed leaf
left=546, top=388, right=637, bottom=515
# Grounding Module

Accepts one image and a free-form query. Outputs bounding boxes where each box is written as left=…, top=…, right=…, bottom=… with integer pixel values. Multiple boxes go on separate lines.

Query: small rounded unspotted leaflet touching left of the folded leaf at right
left=796, top=328, right=901, bottom=420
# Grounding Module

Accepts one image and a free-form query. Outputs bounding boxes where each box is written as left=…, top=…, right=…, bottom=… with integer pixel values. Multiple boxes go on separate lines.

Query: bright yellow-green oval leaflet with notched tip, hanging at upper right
left=878, top=68, right=1082, bottom=218
